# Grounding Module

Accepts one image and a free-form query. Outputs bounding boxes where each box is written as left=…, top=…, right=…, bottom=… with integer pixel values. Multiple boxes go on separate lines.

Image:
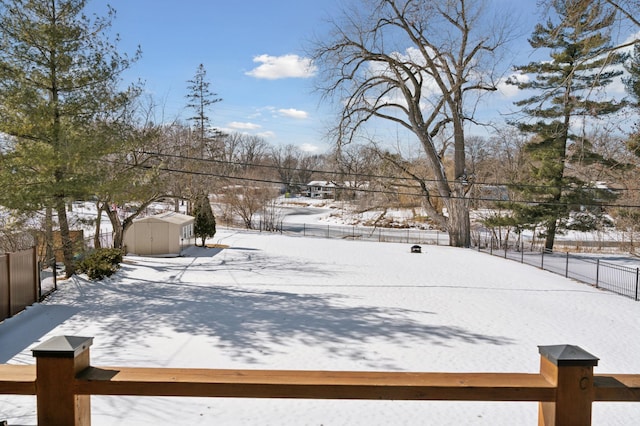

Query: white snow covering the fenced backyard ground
left=0, top=230, right=640, bottom=426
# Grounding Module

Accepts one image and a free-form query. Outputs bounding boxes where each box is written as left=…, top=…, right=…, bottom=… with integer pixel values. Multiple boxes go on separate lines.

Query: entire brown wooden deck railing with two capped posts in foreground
left=0, top=336, right=640, bottom=426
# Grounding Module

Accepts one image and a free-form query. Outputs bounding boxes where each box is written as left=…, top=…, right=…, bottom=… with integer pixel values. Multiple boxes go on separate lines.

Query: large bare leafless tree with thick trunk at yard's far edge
left=314, top=0, right=507, bottom=246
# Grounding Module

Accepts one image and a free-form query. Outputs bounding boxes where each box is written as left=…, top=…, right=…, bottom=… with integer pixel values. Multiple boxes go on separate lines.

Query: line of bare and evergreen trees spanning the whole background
left=0, top=0, right=640, bottom=275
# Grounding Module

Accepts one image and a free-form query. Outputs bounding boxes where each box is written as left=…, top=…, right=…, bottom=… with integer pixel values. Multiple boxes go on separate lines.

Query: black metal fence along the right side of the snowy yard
left=477, top=243, right=640, bottom=301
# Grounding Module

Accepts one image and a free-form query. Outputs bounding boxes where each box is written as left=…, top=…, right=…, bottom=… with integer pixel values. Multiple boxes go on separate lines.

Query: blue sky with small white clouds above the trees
left=88, top=0, right=632, bottom=152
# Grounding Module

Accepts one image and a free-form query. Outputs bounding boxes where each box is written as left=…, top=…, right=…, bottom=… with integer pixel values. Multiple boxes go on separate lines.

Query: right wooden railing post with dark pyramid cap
left=538, top=345, right=598, bottom=426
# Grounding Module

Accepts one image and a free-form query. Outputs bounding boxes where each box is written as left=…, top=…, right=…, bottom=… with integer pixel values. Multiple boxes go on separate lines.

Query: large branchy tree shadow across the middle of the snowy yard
left=55, top=246, right=513, bottom=368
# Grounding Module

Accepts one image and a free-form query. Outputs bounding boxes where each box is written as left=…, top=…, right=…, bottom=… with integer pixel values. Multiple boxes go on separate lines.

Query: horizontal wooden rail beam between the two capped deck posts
left=76, top=367, right=556, bottom=401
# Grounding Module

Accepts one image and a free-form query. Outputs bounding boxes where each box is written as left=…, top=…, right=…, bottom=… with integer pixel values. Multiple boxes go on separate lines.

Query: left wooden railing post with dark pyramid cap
left=32, top=336, right=93, bottom=426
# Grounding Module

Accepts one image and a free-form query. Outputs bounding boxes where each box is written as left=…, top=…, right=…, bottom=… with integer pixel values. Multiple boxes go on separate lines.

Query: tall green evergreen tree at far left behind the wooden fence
left=0, top=0, right=135, bottom=276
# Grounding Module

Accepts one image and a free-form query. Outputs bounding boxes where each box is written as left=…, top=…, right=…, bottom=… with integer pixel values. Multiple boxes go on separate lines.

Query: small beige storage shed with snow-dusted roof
left=124, top=212, right=195, bottom=256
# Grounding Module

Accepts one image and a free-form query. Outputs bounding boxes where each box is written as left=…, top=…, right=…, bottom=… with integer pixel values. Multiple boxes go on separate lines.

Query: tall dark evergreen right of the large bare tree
left=504, top=0, right=625, bottom=250
